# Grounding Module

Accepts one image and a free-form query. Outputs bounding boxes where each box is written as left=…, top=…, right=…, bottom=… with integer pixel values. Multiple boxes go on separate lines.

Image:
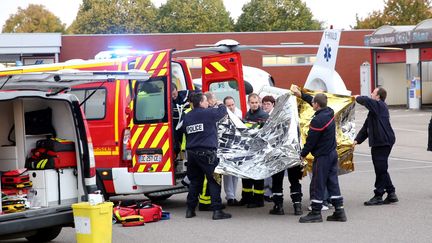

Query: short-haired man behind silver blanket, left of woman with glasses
left=240, top=93, right=269, bottom=208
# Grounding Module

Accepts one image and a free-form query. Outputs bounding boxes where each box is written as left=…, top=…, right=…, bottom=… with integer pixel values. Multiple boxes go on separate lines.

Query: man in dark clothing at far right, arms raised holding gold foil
left=354, top=87, right=399, bottom=206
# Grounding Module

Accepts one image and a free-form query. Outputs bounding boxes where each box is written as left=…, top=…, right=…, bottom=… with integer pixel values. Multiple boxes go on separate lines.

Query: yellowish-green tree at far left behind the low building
left=2, top=4, right=65, bottom=33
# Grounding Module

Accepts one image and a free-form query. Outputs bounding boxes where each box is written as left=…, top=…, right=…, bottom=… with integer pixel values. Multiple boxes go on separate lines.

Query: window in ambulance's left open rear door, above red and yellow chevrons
left=134, top=80, right=167, bottom=123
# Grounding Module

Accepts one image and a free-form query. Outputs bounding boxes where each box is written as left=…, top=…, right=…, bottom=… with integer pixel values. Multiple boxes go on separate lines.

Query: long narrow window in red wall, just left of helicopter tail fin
left=262, top=55, right=316, bottom=67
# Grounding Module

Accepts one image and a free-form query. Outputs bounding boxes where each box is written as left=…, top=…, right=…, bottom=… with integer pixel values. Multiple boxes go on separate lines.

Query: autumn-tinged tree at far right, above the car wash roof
left=354, top=0, right=432, bottom=29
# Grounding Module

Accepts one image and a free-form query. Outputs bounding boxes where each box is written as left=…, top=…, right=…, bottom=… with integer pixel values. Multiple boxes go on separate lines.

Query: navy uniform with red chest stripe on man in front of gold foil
left=301, top=93, right=343, bottom=211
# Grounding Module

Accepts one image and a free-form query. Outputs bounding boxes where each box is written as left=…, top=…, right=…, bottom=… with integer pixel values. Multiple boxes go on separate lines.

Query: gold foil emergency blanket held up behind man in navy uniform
left=297, top=90, right=355, bottom=174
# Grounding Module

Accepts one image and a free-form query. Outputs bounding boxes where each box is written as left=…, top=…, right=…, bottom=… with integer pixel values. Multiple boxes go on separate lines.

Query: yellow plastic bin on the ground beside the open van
left=72, top=202, right=113, bottom=243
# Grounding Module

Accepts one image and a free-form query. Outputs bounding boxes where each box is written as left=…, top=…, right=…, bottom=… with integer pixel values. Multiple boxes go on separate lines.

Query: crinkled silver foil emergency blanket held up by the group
left=215, top=93, right=301, bottom=180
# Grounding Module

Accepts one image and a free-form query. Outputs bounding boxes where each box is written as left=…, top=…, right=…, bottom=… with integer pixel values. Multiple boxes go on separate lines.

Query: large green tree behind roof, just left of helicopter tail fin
left=235, top=0, right=322, bottom=31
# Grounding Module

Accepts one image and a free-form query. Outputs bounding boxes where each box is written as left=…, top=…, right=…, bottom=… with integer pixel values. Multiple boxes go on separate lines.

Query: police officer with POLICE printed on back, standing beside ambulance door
left=183, top=93, right=231, bottom=220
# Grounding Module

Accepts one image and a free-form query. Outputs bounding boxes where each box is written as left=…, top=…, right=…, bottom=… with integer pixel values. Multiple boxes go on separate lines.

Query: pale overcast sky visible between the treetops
left=0, top=0, right=384, bottom=29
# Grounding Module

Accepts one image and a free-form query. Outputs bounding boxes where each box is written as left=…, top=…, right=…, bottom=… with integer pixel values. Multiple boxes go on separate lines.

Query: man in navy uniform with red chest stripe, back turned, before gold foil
left=292, top=85, right=347, bottom=223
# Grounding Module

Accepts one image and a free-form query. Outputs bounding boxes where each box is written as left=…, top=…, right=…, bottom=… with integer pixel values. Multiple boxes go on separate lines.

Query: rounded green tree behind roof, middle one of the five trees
left=158, top=0, right=233, bottom=33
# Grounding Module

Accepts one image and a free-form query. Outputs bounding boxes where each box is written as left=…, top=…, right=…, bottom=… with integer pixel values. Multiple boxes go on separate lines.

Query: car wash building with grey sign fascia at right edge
left=364, top=19, right=432, bottom=109
